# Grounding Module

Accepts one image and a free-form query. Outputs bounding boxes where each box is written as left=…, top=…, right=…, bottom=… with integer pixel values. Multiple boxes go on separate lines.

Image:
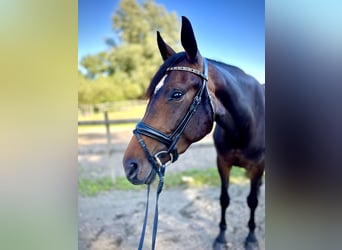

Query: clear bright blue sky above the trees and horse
left=78, top=0, right=265, bottom=83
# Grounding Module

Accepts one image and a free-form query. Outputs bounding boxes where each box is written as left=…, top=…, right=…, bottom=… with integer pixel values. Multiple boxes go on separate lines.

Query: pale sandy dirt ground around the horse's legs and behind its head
left=78, top=130, right=265, bottom=250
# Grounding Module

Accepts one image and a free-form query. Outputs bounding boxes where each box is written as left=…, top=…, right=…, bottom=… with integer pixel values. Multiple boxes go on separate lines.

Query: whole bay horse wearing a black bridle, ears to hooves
left=123, top=17, right=265, bottom=249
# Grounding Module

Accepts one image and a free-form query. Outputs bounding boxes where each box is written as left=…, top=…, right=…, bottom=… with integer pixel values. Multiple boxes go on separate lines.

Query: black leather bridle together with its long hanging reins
left=133, top=58, right=214, bottom=250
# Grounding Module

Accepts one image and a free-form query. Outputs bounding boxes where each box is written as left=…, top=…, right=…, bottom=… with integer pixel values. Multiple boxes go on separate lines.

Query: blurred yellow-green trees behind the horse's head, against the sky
left=79, top=0, right=180, bottom=104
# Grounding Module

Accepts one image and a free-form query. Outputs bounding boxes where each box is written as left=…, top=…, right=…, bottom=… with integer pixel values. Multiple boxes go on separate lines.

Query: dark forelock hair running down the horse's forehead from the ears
left=145, top=52, right=185, bottom=99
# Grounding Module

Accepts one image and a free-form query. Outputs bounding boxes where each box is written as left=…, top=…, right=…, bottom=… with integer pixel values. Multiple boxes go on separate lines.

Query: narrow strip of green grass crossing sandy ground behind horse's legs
left=78, top=167, right=248, bottom=196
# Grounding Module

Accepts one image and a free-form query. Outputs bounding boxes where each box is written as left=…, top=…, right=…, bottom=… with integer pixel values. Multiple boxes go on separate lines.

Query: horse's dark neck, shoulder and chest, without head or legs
left=210, top=61, right=265, bottom=161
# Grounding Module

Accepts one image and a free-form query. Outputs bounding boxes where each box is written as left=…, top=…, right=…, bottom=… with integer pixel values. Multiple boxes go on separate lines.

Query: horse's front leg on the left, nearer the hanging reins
left=214, top=156, right=232, bottom=250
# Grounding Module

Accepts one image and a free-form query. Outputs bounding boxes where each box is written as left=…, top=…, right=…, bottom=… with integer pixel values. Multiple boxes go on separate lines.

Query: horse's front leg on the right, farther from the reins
left=245, top=165, right=264, bottom=250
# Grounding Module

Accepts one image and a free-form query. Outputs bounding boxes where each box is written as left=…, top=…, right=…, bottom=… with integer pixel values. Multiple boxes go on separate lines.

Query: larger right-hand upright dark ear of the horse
left=181, top=16, right=197, bottom=61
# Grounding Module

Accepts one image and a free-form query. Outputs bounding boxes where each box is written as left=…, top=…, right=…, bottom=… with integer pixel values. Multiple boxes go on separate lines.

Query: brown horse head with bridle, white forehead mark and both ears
left=123, top=17, right=215, bottom=184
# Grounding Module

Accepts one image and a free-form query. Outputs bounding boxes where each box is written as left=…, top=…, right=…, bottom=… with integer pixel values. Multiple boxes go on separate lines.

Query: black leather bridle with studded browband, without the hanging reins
left=133, top=58, right=214, bottom=177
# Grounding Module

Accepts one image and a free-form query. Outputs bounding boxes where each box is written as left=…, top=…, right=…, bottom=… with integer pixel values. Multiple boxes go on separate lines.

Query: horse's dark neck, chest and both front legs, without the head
left=208, top=58, right=265, bottom=249
